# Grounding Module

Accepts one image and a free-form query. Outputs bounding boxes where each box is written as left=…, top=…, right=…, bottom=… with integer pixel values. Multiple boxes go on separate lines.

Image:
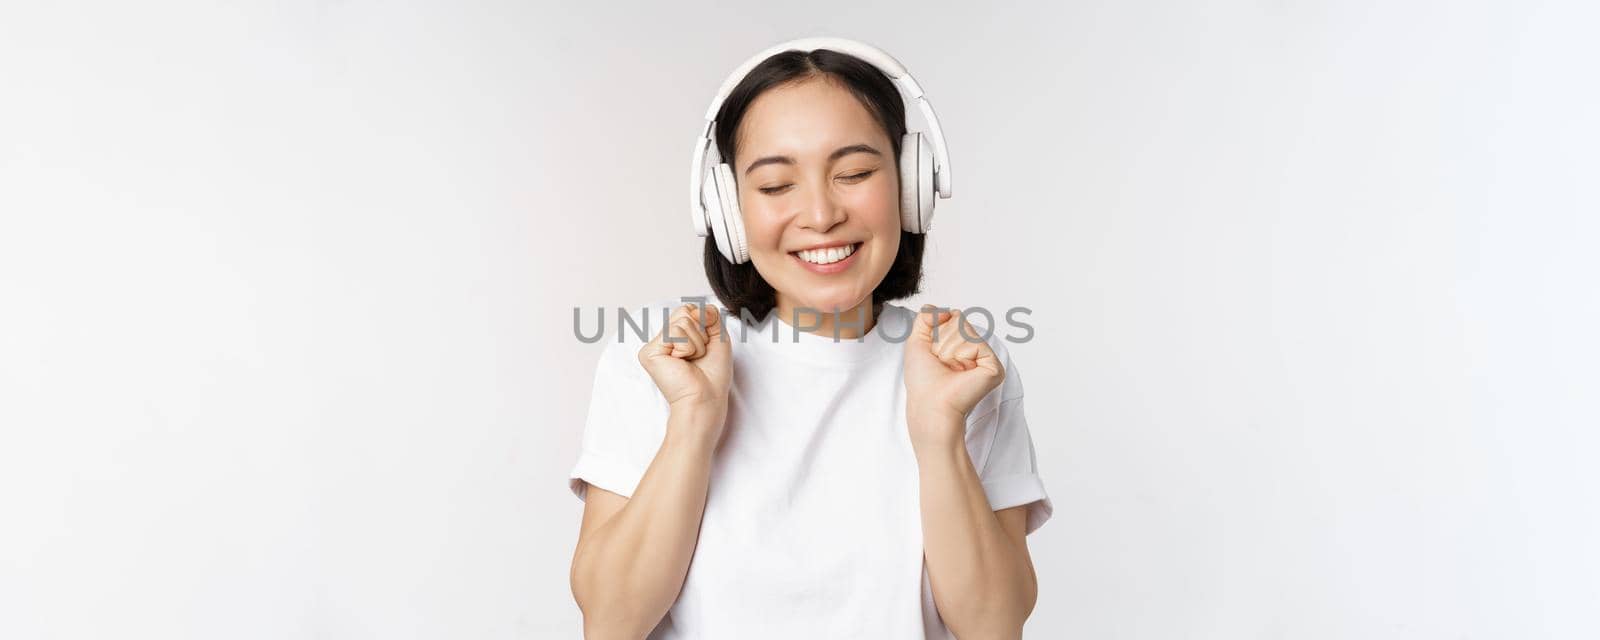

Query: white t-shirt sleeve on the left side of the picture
left=566, top=336, right=670, bottom=501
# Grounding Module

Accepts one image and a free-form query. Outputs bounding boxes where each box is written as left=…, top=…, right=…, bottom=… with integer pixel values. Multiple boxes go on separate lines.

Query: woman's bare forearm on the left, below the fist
left=573, top=410, right=720, bottom=638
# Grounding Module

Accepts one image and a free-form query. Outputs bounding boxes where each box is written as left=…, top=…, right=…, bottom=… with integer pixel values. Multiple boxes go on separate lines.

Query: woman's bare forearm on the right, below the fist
left=915, top=416, right=1037, bottom=640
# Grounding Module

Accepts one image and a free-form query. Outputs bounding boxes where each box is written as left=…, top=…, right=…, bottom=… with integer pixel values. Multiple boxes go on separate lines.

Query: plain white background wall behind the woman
left=0, top=2, right=1600, bottom=638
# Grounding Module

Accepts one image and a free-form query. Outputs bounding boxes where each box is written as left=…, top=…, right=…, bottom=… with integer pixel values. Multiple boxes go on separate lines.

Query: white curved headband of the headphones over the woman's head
left=690, top=37, right=950, bottom=237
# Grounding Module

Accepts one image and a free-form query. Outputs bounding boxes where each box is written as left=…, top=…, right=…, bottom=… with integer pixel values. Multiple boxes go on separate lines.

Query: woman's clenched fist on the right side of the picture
left=906, top=304, right=1005, bottom=443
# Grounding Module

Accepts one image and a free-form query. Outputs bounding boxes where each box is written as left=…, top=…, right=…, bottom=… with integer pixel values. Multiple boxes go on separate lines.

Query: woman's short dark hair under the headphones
left=706, top=50, right=925, bottom=324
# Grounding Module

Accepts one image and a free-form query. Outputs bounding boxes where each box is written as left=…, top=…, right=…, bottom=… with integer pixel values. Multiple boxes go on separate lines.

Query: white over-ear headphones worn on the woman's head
left=690, top=37, right=950, bottom=264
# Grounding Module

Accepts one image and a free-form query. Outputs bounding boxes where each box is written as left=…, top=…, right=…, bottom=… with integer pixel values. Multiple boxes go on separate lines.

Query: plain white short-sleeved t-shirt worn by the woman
left=568, top=294, right=1053, bottom=640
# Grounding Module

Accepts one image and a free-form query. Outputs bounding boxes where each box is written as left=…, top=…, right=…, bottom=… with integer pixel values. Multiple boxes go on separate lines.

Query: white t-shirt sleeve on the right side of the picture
left=966, top=339, right=1054, bottom=533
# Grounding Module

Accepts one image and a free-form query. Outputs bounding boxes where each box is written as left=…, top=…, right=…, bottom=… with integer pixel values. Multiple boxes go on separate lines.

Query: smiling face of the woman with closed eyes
left=733, top=77, right=901, bottom=322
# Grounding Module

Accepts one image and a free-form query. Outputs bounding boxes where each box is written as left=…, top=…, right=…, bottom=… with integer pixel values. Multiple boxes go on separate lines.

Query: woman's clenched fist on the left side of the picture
left=638, top=304, right=733, bottom=435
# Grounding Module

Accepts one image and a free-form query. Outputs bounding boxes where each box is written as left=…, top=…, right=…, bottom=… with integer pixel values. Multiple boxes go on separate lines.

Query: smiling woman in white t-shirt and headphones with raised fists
left=570, top=40, right=1053, bottom=638
